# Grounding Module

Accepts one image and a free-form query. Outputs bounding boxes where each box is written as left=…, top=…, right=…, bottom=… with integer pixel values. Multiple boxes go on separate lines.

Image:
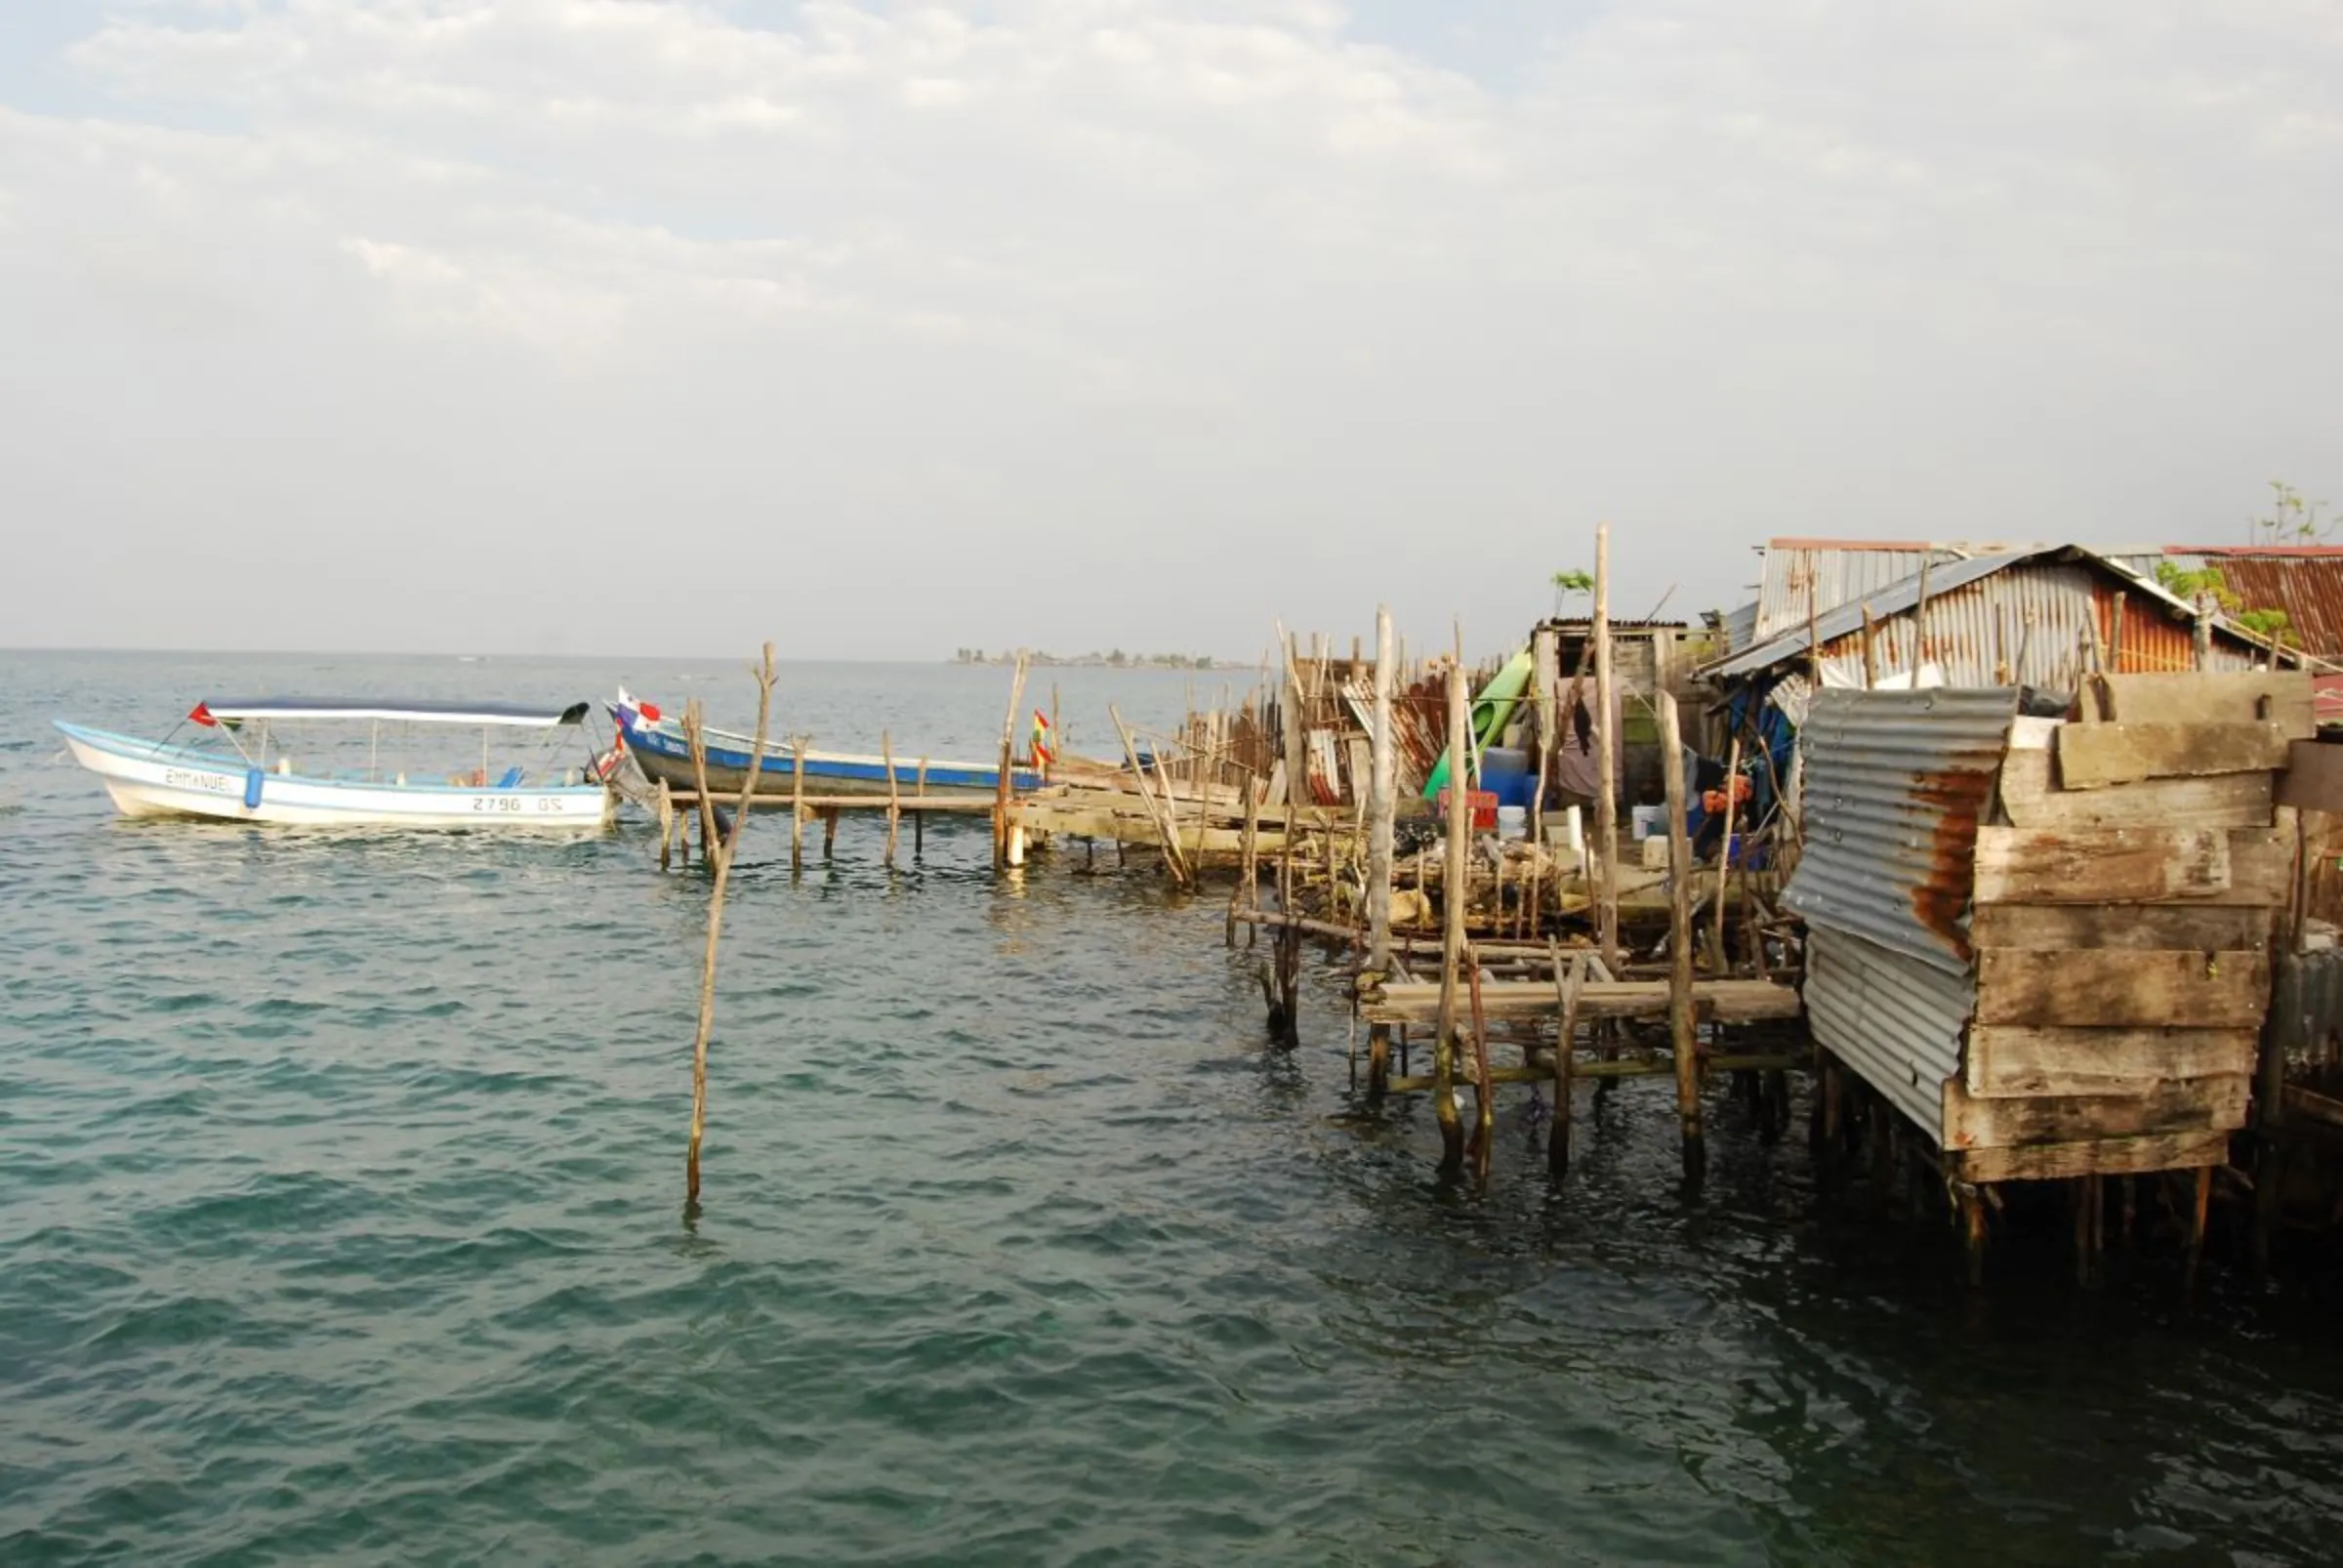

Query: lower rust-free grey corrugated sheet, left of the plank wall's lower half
left=1806, top=926, right=1978, bottom=1148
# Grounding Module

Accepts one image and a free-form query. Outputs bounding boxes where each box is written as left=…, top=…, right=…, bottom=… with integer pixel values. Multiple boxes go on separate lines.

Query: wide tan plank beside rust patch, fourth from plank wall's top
left=1975, top=827, right=2291, bottom=905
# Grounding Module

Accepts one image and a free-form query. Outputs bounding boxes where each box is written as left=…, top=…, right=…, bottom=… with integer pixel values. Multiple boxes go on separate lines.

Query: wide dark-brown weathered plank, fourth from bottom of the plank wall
left=1978, top=947, right=2271, bottom=1029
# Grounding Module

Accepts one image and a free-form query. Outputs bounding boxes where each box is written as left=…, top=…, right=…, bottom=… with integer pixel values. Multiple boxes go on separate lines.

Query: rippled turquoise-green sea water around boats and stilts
left=0, top=654, right=2343, bottom=1566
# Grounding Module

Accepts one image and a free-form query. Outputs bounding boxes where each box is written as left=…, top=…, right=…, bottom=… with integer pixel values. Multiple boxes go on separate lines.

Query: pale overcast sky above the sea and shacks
left=0, top=0, right=2343, bottom=659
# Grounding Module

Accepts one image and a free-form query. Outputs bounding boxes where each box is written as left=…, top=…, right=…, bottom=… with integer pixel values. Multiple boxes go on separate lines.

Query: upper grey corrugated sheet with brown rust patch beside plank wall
left=1783, top=686, right=2017, bottom=975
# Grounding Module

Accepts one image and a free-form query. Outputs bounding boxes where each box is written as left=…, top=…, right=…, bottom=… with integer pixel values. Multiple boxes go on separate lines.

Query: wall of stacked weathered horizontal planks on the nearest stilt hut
left=1943, top=673, right=2313, bottom=1181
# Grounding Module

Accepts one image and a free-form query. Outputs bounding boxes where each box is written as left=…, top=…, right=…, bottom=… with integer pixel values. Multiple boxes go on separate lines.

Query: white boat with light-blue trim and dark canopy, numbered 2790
left=57, top=698, right=616, bottom=830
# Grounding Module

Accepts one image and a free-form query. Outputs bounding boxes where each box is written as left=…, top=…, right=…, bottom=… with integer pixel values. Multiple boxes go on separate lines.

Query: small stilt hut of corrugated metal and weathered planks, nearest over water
left=1786, top=671, right=2313, bottom=1256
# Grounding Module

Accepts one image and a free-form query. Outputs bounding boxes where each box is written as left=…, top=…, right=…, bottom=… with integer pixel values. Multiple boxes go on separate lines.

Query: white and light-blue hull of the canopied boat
left=59, top=724, right=611, bottom=832
